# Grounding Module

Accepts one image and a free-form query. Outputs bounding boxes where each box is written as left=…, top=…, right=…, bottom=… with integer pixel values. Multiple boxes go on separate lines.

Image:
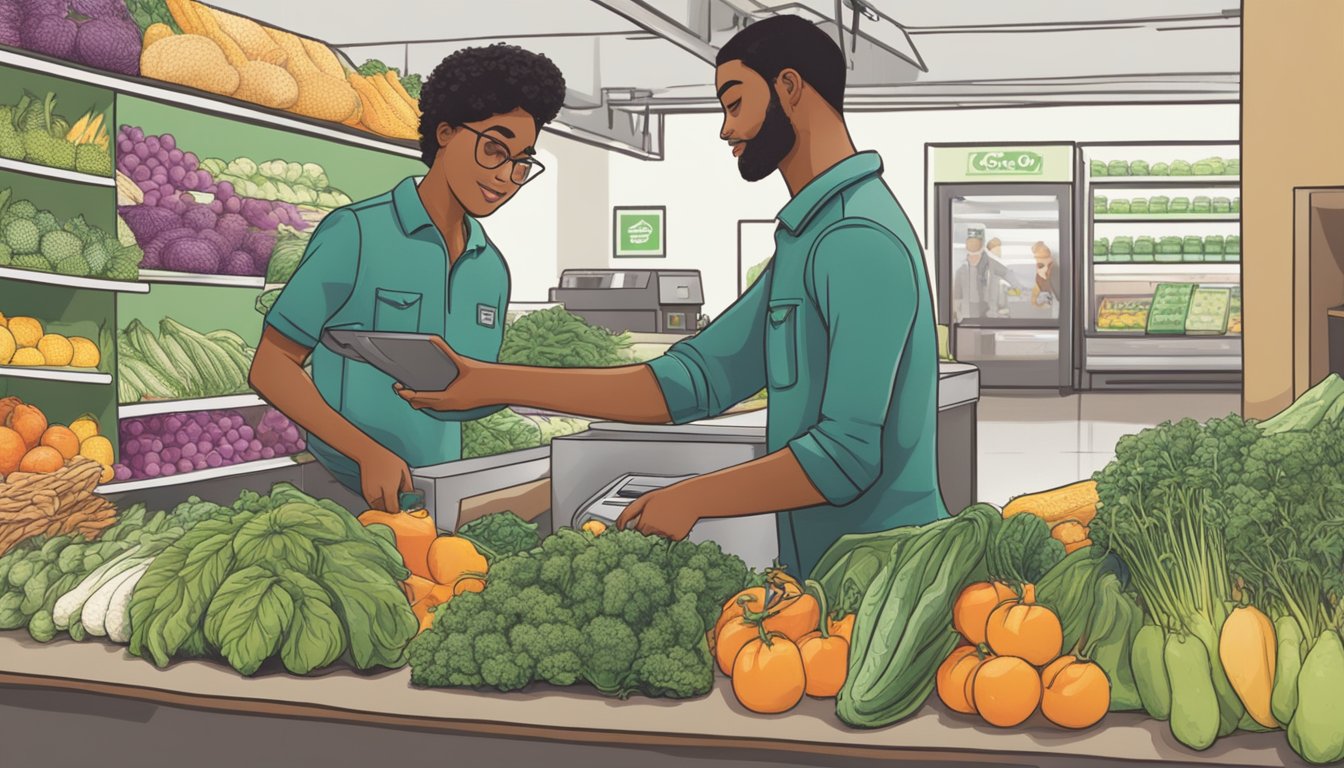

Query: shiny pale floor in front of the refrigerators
left=977, top=393, right=1241, bottom=506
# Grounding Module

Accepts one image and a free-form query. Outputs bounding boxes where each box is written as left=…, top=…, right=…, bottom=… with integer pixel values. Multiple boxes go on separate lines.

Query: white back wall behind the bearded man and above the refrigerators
left=602, top=105, right=1239, bottom=316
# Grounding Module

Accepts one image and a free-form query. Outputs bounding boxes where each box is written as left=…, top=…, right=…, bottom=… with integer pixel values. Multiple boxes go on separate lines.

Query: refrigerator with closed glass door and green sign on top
left=929, top=145, right=1074, bottom=390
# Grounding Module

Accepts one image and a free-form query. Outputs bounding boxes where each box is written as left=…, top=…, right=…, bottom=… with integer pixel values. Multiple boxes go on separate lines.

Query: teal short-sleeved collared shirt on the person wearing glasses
left=266, top=179, right=509, bottom=492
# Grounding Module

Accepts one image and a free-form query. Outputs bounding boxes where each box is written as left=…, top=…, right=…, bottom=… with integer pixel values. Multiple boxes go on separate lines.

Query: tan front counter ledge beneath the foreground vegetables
left=0, top=640, right=1304, bottom=768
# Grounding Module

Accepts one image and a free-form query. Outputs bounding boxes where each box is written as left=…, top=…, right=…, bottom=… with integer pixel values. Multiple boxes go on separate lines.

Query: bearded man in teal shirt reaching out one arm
left=401, top=15, right=946, bottom=576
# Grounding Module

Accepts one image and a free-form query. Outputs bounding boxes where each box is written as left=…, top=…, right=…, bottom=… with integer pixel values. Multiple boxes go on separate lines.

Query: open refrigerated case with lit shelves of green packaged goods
left=1075, top=141, right=1242, bottom=390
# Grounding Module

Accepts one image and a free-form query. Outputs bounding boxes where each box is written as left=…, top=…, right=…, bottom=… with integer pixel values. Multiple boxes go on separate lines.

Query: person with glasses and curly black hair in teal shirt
left=250, top=44, right=564, bottom=511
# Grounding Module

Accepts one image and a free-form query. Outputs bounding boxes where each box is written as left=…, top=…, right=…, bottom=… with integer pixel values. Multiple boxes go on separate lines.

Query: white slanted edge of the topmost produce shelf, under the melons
left=0, top=46, right=421, bottom=160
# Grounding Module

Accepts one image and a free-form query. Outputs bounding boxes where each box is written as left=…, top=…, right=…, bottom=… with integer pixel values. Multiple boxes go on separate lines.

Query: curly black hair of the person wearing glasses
left=419, top=43, right=564, bottom=165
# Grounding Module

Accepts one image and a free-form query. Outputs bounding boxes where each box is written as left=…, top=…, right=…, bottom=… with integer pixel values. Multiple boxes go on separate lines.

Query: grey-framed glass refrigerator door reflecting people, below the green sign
left=937, top=184, right=1074, bottom=389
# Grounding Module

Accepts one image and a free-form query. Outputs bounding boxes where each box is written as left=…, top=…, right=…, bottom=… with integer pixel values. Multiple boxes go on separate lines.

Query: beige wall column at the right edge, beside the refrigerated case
left=1242, top=0, right=1344, bottom=418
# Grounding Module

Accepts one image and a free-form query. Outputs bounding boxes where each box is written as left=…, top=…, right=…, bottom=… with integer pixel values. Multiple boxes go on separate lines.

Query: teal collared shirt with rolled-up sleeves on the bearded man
left=649, top=152, right=948, bottom=577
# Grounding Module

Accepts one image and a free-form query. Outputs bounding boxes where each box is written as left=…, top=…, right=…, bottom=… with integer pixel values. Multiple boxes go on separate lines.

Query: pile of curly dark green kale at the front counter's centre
left=409, top=529, right=749, bottom=698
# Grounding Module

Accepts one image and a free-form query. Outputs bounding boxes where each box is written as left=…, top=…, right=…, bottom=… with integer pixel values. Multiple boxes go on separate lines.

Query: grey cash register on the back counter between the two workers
left=550, top=269, right=707, bottom=335
